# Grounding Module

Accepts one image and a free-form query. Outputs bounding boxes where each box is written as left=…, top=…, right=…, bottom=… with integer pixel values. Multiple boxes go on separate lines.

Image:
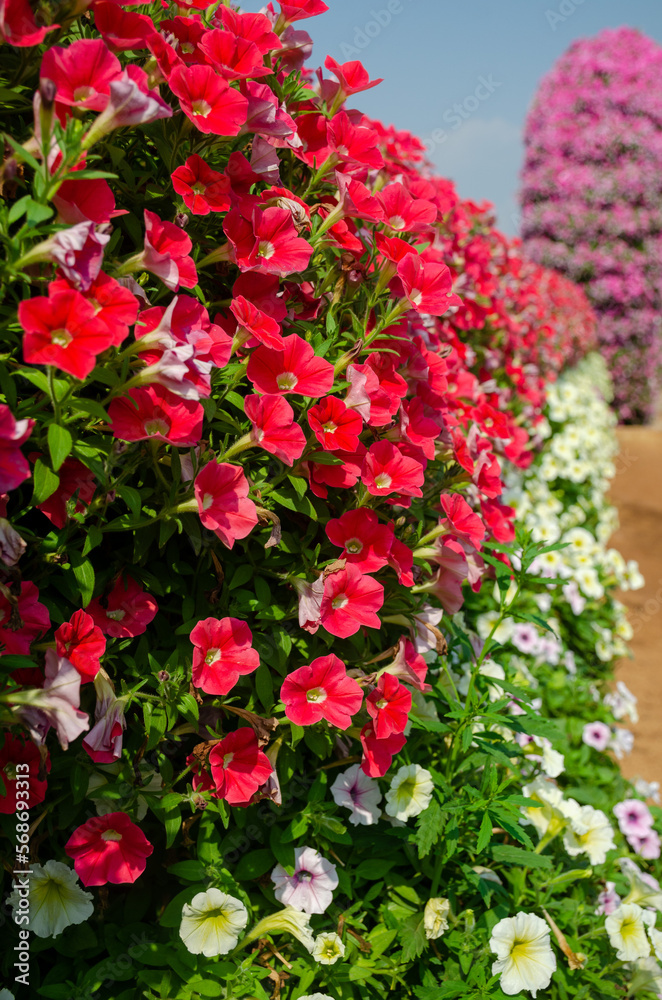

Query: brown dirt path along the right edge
left=610, top=426, right=662, bottom=784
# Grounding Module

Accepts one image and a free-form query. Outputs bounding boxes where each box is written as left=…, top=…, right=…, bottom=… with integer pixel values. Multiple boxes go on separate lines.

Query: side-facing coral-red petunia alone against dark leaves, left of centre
left=195, top=462, right=257, bottom=549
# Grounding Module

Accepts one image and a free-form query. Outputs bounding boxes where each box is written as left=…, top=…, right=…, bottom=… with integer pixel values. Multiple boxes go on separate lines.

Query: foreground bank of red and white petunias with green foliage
left=0, top=0, right=662, bottom=1000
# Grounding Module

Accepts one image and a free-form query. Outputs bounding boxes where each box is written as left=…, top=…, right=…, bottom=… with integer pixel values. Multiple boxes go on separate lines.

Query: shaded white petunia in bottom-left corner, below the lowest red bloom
left=7, top=861, right=94, bottom=937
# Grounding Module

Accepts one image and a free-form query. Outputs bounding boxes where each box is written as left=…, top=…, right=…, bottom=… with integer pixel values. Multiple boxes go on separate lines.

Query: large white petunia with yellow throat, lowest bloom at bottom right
left=490, top=911, right=556, bottom=997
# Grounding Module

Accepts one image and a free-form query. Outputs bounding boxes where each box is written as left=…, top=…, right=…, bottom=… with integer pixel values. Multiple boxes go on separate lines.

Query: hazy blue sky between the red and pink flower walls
left=242, top=0, right=662, bottom=234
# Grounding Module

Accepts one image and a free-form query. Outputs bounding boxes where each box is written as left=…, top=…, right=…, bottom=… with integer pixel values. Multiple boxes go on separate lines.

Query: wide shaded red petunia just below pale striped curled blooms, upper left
left=108, top=383, right=204, bottom=448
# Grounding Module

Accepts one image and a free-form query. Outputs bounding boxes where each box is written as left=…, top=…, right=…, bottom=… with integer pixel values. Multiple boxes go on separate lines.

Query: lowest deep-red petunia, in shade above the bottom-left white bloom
left=64, top=812, right=154, bottom=885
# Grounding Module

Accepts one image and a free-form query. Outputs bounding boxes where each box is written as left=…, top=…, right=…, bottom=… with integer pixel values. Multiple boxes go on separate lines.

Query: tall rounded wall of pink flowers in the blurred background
left=521, top=28, right=662, bottom=423
